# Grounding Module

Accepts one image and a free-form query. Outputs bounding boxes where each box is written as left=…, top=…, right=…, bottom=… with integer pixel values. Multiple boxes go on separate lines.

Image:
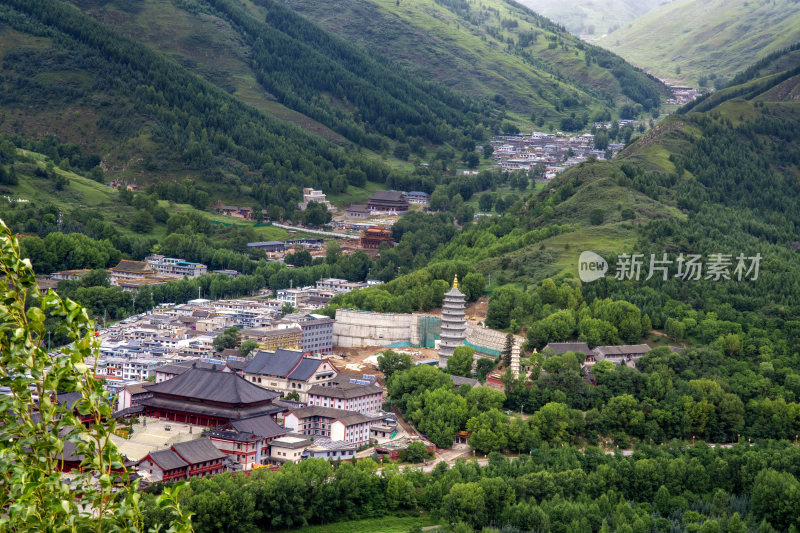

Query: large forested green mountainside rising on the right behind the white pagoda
left=348, top=47, right=800, bottom=342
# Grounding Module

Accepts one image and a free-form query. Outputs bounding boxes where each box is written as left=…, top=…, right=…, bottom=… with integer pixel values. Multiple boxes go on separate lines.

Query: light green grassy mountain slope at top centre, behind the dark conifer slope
left=272, top=0, right=663, bottom=124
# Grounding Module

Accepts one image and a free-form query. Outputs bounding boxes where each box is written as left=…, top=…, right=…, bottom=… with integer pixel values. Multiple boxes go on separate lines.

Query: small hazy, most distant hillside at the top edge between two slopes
left=520, top=0, right=663, bottom=39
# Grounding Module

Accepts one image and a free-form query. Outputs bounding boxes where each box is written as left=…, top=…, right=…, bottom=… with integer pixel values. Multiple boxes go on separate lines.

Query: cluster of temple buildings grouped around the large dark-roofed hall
left=115, top=349, right=433, bottom=482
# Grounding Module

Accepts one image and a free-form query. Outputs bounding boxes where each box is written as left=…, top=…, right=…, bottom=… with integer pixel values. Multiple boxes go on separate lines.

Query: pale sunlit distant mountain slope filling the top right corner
left=598, top=0, right=800, bottom=84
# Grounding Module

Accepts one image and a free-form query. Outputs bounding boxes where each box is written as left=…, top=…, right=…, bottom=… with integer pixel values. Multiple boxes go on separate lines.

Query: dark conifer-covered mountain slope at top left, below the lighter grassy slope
left=72, top=0, right=496, bottom=150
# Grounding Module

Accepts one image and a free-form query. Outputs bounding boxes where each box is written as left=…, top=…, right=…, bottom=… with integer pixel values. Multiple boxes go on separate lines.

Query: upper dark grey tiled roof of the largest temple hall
left=146, top=368, right=279, bottom=404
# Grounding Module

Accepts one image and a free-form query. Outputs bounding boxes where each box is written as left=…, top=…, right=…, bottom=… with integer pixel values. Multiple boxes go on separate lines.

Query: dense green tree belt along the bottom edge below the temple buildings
left=144, top=442, right=800, bottom=533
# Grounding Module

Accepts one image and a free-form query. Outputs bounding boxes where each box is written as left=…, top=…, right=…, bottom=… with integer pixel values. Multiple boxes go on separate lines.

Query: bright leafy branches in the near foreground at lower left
left=0, top=217, right=192, bottom=533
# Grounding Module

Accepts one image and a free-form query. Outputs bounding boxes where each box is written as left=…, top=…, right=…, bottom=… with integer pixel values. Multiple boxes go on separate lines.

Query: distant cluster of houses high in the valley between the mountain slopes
left=491, top=131, right=623, bottom=180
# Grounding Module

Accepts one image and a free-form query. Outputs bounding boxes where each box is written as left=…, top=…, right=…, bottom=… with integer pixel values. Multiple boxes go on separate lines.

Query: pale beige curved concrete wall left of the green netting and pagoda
left=333, top=309, right=419, bottom=348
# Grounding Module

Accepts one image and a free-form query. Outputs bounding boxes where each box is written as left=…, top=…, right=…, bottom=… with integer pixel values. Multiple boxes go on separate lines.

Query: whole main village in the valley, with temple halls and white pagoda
left=43, top=264, right=668, bottom=485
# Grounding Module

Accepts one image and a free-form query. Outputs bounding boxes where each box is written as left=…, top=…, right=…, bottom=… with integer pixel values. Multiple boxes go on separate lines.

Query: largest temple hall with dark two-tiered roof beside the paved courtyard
left=140, top=368, right=287, bottom=426
